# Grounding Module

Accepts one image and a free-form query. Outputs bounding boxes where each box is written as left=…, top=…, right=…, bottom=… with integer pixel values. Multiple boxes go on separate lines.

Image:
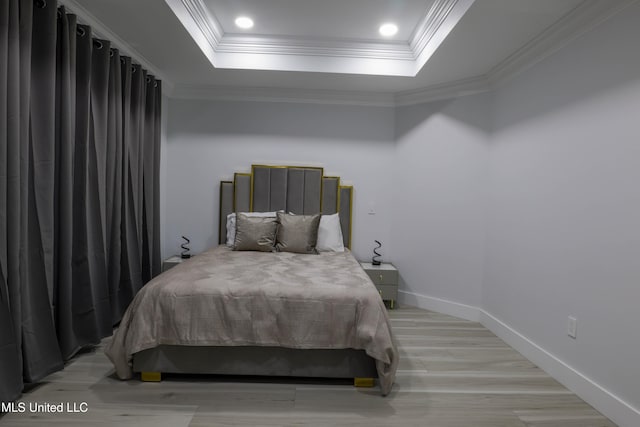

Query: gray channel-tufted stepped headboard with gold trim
left=219, top=165, right=353, bottom=248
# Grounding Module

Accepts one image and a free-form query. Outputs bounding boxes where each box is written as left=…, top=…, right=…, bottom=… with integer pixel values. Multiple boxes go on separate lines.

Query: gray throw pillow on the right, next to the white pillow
left=276, top=212, right=320, bottom=254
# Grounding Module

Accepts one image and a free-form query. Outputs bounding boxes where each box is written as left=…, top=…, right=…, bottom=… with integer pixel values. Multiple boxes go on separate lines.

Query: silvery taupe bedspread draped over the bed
left=105, top=246, right=398, bottom=395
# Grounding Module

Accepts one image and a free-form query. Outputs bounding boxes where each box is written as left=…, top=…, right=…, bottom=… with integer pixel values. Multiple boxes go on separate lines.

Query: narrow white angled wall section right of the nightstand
left=392, top=95, right=491, bottom=314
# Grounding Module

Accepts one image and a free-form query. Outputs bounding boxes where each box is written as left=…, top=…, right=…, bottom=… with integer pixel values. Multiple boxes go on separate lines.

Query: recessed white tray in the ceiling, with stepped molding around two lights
left=165, top=0, right=475, bottom=77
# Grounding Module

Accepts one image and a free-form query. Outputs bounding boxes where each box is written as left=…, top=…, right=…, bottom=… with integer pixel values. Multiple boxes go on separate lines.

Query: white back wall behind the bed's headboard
left=162, top=99, right=394, bottom=259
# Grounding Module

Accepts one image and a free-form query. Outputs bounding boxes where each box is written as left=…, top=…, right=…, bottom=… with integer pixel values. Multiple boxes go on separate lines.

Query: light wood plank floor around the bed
left=0, top=307, right=614, bottom=427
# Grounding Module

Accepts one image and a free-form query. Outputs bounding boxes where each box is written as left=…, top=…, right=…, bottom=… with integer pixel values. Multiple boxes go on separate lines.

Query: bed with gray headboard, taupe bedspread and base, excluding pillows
left=105, top=166, right=398, bottom=395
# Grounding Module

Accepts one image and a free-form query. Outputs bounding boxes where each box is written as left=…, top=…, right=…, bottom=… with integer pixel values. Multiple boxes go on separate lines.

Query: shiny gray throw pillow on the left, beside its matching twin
left=233, top=213, right=278, bottom=252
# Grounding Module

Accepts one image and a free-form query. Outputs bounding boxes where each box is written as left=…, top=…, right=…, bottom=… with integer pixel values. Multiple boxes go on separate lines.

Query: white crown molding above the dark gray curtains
left=58, top=0, right=174, bottom=95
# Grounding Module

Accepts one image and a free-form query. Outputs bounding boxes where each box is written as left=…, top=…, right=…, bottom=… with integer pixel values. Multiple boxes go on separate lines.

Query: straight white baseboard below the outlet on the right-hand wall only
left=480, top=310, right=640, bottom=427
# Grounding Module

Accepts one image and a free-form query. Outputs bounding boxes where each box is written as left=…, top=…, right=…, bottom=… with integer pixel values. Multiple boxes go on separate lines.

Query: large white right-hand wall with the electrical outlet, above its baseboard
left=483, top=5, right=640, bottom=425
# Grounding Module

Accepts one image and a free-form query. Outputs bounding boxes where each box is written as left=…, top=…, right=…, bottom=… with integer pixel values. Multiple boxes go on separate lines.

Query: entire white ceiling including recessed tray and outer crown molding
left=58, top=0, right=638, bottom=105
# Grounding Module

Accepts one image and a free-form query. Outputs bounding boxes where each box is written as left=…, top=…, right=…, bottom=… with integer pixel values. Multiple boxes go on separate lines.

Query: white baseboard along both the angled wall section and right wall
left=398, top=291, right=640, bottom=427
